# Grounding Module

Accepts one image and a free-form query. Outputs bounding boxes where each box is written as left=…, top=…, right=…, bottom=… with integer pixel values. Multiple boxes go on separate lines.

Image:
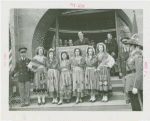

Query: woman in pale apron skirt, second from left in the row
left=46, top=48, right=59, bottom=104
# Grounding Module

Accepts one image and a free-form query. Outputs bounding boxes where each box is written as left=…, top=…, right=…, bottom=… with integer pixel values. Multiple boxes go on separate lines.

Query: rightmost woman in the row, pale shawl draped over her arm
left=97, top=43, right=115, bottom=102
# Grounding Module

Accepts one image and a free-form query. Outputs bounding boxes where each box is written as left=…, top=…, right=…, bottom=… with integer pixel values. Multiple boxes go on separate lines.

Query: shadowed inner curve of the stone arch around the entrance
left=32, top=9, right=132, bottom=56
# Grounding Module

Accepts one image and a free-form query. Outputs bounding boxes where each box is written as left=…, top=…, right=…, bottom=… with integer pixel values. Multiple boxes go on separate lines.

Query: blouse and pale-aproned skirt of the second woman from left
left=46, top=58, right=60, bottom=97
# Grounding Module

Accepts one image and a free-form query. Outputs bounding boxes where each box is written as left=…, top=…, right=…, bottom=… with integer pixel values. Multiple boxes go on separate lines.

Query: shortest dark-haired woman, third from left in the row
left=58, top=52, right=72, bottom=105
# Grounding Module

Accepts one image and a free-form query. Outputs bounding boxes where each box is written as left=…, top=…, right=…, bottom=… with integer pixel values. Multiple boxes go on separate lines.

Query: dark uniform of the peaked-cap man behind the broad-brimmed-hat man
left=118, top=50, right=129, bottom=100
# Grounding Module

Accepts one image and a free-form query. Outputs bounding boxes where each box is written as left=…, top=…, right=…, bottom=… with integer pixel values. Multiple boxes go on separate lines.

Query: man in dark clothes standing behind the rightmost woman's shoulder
left=104, top=33, right=118, bottom=76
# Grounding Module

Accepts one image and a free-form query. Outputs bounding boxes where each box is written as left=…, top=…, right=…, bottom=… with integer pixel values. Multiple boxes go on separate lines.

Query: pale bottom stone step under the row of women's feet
left=10, top=100, right=131, bottom=111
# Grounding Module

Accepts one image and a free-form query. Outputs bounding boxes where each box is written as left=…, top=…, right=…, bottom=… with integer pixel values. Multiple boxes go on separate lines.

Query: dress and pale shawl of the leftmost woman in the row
left=32, top=55, right=47, bottom=93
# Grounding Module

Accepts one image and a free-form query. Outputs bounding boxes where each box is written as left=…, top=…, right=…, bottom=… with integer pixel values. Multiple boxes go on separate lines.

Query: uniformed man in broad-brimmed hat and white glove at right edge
left=124, top=37, right=143, bottom=111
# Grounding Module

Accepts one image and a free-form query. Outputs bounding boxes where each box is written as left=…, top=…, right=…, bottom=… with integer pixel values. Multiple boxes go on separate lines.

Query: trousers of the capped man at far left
left=19, top=81, right=30, bottom=104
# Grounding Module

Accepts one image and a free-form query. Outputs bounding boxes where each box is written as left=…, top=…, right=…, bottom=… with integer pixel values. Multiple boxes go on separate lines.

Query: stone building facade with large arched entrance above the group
left=10, top=9, right=143, bottom=68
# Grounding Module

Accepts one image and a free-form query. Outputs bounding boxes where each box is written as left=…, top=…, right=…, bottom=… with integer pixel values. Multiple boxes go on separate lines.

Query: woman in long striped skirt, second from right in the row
left=85, top=47, right=97, bottom=102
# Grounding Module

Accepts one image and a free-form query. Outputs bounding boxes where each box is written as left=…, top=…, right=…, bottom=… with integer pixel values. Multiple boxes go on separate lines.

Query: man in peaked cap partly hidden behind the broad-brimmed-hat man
left=118, top=37, right=130, bottom=104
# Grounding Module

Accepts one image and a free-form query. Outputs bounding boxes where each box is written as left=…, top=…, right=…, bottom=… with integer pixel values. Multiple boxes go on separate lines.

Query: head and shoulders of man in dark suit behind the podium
left=74, top=31, right=90, bottom=46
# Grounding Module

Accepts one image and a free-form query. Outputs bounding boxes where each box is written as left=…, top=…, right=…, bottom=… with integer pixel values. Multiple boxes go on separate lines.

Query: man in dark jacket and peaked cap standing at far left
left=11, top=47, right=33, bottom=107
